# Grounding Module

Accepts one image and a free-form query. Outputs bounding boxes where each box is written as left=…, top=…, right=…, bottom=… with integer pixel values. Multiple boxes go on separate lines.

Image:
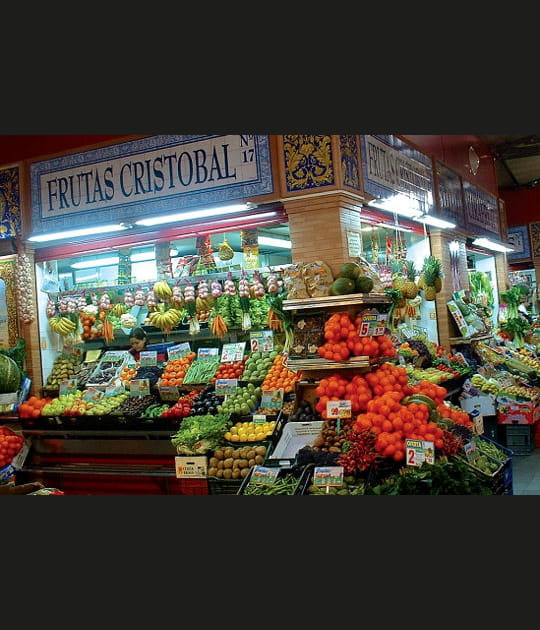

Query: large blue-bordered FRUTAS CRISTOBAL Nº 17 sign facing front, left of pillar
left=30, top=134, right=274, bottom=234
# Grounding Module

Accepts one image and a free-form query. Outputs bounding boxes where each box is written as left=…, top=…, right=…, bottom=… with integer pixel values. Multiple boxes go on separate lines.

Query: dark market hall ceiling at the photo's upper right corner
left=479, top=135, right=540, bottom=190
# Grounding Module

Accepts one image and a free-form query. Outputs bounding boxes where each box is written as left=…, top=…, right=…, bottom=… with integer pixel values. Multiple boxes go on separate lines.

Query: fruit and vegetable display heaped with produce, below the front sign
left=1, top=260, right=528, bottom=495
